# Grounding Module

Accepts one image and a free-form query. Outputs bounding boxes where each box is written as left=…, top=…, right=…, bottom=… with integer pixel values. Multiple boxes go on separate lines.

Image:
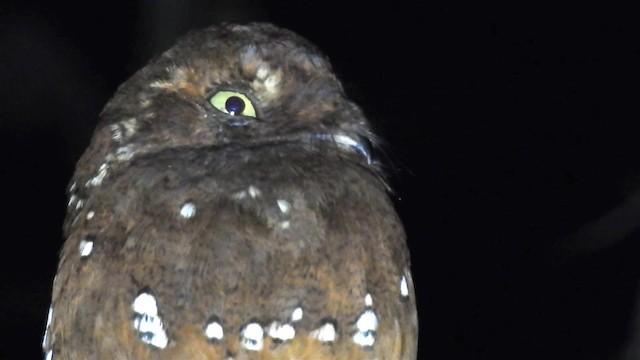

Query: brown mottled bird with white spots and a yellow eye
left=42, top=23, right=418, bottom=360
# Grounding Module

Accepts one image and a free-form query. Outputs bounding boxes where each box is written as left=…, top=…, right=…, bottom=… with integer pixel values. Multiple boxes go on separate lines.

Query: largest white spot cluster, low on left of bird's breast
left=132, top=292, right=169, bottom=349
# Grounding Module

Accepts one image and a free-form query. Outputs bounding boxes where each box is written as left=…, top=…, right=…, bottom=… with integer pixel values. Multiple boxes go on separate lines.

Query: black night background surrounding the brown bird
left=0, top=0, right=640, bottom=359
